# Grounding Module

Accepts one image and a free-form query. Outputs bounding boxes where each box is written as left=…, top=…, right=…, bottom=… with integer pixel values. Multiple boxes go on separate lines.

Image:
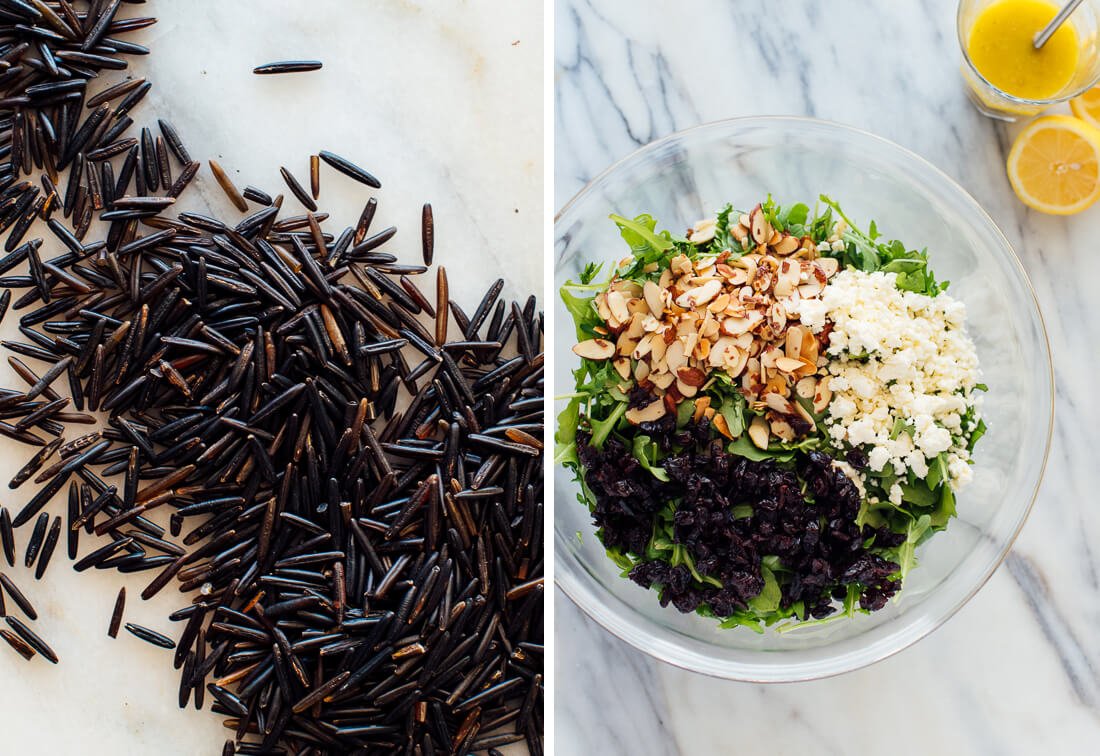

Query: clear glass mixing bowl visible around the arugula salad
left=554, top=118, right=1054, bottom=682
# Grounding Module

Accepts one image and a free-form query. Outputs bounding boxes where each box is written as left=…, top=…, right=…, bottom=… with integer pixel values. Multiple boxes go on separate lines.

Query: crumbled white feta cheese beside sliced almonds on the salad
left=800, top=270, right=979, bottom=490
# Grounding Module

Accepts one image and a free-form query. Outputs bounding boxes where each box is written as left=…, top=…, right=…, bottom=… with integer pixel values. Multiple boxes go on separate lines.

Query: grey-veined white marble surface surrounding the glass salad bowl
left=554, top=0, right=1100, bottom=756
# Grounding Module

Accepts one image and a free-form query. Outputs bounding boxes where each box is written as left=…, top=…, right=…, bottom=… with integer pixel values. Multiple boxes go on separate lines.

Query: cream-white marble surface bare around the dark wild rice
left=0, top=0, right=543, bottom=756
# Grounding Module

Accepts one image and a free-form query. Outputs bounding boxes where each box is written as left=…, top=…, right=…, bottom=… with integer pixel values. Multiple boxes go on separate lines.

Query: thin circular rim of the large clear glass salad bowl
left=551, top=116, right=1056, bottom=683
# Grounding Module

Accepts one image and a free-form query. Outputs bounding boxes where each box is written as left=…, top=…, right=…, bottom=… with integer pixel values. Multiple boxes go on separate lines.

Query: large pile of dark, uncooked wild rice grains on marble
left=0, top=0, right=543, bottom=754
